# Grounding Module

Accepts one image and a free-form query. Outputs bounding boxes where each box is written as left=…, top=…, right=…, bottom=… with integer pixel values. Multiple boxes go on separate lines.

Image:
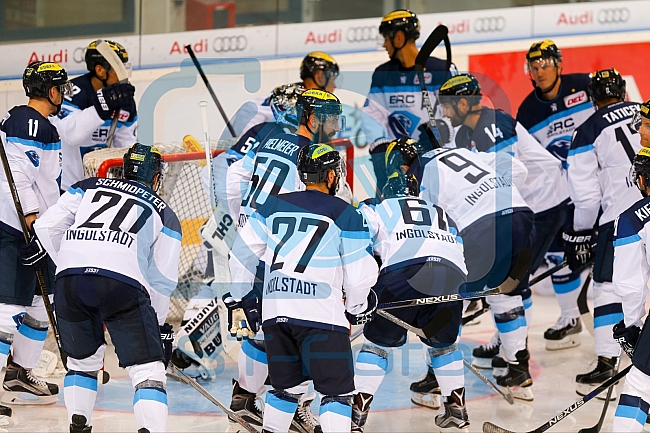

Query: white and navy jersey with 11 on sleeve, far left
left=0, top=105, right=61, bottom=236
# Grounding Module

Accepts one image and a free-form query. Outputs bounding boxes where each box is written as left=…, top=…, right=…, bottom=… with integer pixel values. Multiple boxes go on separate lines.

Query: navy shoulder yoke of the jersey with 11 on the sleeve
left=0, top=105, right=61, bottom=150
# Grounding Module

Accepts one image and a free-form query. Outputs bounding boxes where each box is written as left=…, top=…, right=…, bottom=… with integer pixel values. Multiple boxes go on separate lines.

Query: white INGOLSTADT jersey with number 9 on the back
left=409, top=148, right=528, bottom=234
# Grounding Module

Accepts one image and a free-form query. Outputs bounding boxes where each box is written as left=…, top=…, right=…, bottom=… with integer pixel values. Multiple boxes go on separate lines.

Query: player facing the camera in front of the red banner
left=517, top=40, right=595, bottom=350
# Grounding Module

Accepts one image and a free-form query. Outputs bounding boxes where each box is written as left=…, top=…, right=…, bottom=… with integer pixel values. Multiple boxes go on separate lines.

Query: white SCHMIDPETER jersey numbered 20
left=34, top=177, right=182, bottom=324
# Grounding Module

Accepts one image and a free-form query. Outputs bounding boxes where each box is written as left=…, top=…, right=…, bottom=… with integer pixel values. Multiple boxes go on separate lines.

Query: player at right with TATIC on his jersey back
left=563, top=69, right=641, bottom=397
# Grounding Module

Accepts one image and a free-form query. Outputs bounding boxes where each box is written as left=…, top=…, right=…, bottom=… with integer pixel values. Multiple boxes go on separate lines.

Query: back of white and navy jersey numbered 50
left=239, top=134, right=311, bottom=227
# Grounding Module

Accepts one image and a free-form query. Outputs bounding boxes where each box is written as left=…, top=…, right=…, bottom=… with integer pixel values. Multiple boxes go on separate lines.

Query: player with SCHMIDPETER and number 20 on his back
left=35, top=143, right=182, bottom=433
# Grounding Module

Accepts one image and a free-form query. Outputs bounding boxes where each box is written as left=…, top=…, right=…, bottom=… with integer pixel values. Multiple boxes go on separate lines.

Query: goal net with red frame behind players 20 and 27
left=83, top=138, right=354, bottom=324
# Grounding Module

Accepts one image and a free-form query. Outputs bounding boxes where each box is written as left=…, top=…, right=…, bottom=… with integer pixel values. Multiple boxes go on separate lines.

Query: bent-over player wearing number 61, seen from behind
left=352, top=137, right=469, bottom=432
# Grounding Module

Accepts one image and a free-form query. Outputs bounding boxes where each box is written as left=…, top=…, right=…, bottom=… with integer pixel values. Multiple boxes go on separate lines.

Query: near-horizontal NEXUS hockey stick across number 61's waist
left=377, top=248, right=532, bottom=310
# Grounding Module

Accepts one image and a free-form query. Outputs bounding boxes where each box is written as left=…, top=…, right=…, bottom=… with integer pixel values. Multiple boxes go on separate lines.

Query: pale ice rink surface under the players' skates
left=2, top=276, right=629, bottom=433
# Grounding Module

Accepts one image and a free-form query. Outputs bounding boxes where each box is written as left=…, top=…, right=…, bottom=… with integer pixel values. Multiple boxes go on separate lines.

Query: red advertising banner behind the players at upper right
left=469, top=42, right=650, bottom=115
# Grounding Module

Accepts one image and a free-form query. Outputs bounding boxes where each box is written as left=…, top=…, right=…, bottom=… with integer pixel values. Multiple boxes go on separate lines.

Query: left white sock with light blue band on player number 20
left=63, top=370, right=98, bottom=424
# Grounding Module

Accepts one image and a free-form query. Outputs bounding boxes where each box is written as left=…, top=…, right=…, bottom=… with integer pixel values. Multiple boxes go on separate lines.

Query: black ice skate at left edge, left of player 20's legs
left=0, top=362, right=59, bottom=405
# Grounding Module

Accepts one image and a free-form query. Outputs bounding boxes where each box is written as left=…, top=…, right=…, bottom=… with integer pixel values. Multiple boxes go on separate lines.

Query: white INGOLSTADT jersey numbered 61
left=359, top=197, right=467, bottom=275
